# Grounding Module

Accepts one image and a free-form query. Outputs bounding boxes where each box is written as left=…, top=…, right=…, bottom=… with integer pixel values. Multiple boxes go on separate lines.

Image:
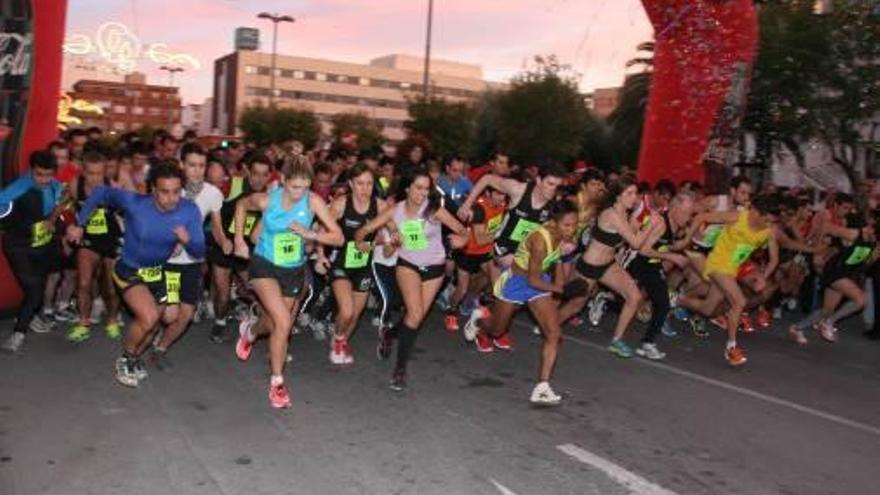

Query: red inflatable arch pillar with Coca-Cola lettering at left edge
left=0, top=0, right=67, bottom=310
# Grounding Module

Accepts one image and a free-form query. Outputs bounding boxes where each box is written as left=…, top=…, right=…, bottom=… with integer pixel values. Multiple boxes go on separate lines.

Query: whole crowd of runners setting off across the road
left=0, top=129, right=880, bottom=408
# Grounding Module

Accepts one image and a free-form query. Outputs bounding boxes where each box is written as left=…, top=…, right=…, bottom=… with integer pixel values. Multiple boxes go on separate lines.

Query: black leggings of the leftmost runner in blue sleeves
left=3, top=246, right=51, bottom=333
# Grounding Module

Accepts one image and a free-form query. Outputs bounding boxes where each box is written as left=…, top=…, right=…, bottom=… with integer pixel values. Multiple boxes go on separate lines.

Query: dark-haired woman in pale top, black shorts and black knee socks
left=354, top=167, right=468, bottom=391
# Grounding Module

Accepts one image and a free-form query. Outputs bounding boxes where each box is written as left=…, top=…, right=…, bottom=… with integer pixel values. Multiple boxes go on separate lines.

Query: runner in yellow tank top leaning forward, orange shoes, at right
left=678, top=194, right=779, bottom=366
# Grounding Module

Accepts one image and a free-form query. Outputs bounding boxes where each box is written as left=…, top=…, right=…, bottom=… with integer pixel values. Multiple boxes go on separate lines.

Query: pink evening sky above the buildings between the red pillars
left=67, top=0, right=652, bottom=103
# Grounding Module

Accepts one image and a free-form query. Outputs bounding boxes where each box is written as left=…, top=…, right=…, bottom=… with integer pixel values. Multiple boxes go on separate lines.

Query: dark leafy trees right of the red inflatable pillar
left=744, top=0, right=880, bottom=181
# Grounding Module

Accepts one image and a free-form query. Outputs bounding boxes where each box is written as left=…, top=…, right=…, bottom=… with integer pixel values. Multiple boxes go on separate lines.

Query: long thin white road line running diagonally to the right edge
left=513, top=320, right=880, bottom=436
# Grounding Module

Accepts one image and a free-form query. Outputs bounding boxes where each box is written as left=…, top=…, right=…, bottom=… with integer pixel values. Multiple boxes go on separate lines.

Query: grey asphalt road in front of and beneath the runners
left=0, top=306, right=880, bottom=495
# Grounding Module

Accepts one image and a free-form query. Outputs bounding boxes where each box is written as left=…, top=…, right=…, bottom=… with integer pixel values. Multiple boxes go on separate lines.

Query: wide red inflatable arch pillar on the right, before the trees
left=638, top=0, right=758, bottom=190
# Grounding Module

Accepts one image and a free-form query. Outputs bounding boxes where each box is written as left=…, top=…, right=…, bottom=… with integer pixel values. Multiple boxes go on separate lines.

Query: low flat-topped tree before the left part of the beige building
left=239, top=106, right=321, bottom=149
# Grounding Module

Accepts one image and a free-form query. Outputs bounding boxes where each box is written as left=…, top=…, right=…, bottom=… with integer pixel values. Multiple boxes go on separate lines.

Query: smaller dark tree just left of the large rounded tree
left=403, top=97, right=475, bottom=158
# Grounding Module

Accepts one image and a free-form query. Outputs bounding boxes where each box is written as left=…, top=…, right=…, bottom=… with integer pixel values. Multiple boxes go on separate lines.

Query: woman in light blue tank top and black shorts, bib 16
left=235, top=158, right=344, bottom=408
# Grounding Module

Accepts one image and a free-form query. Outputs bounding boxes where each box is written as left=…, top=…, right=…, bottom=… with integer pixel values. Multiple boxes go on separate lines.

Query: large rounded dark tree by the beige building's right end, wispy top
left=497, top=55, right=588, bottom=164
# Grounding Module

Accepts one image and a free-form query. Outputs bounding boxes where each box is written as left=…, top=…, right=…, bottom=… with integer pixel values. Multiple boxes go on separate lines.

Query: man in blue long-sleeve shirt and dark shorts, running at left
left=67, top=161, right=205, bottom=387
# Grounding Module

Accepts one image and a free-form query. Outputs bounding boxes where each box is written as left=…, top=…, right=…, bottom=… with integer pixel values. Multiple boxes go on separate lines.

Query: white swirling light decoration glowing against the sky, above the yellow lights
left=64, top=22, right=201, bottom=72
